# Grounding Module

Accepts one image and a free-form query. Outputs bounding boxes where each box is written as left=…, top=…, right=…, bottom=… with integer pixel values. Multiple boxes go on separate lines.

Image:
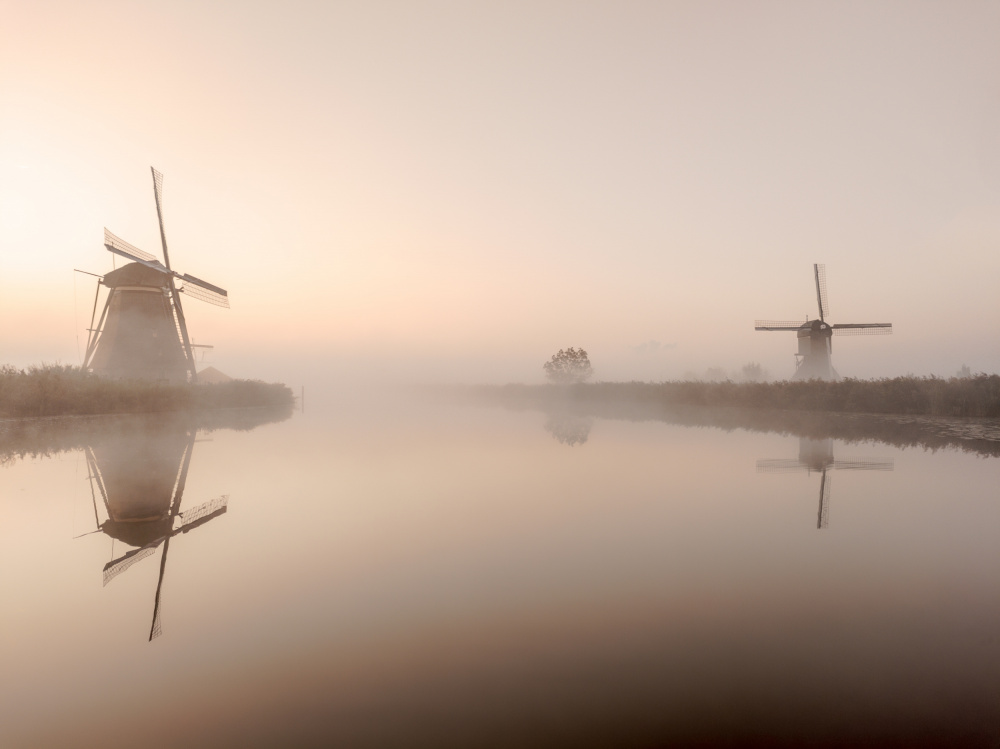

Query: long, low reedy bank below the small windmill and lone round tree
left=479, top=374, right=1000, bottom=418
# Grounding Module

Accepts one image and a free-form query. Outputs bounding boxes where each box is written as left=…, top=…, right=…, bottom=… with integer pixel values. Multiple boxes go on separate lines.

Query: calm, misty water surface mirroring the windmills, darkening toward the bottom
left=0, top=400, right=1000, bottom=747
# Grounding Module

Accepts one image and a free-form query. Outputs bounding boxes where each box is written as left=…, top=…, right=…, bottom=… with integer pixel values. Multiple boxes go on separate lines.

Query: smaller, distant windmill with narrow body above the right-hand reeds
left=754, top=265, right=892, bottom=380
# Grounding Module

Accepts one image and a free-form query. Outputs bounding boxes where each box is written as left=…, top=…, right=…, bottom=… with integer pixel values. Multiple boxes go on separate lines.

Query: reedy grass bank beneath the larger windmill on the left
left=0, top=364, right=294, bottom=418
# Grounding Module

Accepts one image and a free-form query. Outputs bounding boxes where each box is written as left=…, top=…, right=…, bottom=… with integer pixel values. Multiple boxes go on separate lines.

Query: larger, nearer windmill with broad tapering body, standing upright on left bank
left=83, top=167, right=229, bottom=382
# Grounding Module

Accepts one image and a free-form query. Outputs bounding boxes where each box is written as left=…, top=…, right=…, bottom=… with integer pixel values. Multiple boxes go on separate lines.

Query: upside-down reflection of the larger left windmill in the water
left=85, top=422, right=229, bottom=640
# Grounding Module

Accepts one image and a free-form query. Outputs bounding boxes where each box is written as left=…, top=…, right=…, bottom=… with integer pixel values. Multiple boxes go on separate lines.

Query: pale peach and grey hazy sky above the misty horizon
left=0, top=0, right=1000, bottom=385
